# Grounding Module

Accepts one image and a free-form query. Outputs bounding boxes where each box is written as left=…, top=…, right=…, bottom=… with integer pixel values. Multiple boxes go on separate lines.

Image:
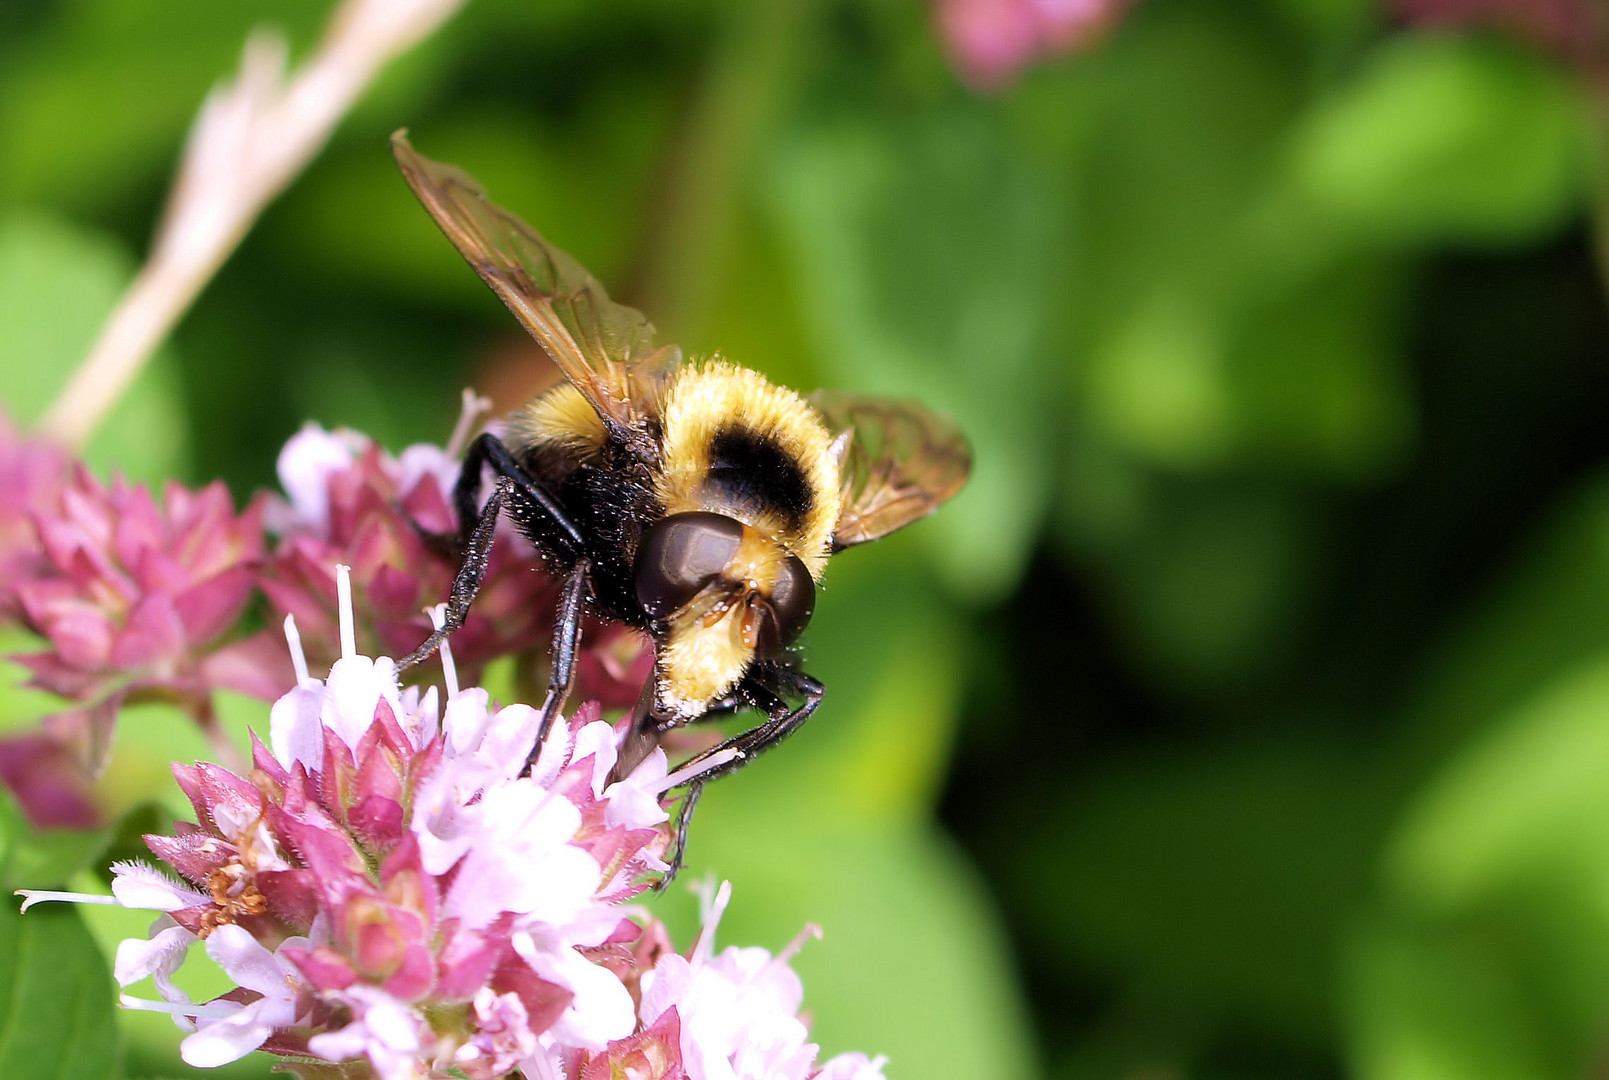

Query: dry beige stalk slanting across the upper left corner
left=40, top=0, right=463, bottom=447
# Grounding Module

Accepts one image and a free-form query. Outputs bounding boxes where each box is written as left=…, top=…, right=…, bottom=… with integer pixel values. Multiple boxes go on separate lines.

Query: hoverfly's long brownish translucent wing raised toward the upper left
left=400, top=129, right=682, bottom=427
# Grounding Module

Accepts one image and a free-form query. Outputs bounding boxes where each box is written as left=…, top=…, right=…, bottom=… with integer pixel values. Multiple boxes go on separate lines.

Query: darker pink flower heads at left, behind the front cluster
left=0, top=402, right=653, bottom=826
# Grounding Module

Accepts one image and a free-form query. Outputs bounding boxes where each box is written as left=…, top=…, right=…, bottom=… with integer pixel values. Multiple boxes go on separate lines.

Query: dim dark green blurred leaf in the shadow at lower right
left=999, top=742, right=1382, bottom=1043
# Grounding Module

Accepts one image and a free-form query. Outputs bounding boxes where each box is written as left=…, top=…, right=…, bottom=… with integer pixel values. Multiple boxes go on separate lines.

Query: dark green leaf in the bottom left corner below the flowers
left=0, top=897, right=122, bottom=1080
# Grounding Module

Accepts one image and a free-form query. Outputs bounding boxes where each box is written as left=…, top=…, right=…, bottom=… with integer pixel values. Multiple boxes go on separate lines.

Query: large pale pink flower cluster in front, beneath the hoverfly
left=26, top=570, right=882, bottom=1080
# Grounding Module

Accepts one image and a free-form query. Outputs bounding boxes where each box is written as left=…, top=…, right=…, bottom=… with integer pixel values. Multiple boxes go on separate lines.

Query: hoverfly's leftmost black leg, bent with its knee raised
left=397, top=433, right=582, bottom=671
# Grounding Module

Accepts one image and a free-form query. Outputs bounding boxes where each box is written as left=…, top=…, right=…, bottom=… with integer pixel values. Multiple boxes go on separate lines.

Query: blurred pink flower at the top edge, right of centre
left=935, top=0, right=1130, bottom=90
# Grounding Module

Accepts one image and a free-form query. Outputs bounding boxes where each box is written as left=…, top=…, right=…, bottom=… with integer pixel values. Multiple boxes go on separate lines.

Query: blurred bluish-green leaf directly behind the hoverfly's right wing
left=769, top=106, right=1060, bottom=597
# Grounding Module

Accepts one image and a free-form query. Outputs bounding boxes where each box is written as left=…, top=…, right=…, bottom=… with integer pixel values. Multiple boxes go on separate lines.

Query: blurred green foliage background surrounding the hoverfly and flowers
left=9, top=0, right=1609, bottom=1080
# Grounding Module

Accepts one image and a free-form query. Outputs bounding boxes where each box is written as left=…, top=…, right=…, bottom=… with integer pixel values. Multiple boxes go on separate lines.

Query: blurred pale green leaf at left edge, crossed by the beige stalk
left=0, top=214, right=187, bottom=483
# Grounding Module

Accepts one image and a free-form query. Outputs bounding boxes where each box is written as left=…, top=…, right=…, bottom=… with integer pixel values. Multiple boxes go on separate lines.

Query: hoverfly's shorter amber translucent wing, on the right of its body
left=811, top=391, right=972, bottom=549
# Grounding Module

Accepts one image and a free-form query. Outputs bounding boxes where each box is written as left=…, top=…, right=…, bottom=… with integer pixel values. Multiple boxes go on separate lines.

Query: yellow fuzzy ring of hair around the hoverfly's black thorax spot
left=655, top=361, right=840, bottom=581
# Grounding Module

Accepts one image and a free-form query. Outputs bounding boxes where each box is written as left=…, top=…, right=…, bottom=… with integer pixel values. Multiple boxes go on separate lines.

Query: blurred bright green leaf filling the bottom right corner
left=1352, top=657, right=1609, bottom=1080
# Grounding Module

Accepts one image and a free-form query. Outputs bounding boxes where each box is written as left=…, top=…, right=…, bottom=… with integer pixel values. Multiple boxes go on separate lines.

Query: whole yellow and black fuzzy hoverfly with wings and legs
left=391, top=132, right=972, bottom=879
